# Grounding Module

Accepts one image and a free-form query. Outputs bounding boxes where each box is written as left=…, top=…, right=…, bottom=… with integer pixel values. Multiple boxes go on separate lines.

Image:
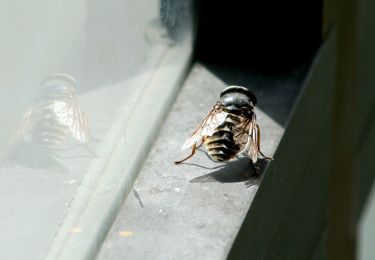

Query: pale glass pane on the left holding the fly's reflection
left=0, top=0, right=192, bottom=259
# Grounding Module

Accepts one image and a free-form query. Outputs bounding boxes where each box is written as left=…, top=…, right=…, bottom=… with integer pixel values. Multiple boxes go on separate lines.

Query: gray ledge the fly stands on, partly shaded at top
left=98, top=58, right=308, bottom=259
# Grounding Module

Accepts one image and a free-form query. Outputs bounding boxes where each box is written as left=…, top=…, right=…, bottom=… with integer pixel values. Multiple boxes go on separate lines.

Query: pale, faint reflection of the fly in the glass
left=13, top=73, right=96, bottom=155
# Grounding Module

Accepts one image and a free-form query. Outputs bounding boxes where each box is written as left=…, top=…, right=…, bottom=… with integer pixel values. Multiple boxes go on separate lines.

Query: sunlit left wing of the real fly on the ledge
left=181, top=108, right=228, bottom=150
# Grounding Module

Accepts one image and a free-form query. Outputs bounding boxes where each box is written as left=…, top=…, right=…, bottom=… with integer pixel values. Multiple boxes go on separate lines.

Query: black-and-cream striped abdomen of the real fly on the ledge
left=205, top=114, right=240, bottom=162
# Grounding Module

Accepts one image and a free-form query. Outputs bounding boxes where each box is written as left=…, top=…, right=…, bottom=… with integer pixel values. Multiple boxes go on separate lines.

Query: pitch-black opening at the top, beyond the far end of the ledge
left=195, top=0, right=323, bottom=76
